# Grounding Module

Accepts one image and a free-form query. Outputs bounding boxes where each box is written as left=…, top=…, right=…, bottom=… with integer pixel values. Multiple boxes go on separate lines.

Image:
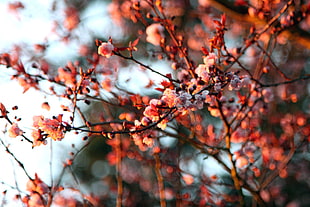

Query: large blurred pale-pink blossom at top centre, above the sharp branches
left=146, top=23, right=165, bottom=46
